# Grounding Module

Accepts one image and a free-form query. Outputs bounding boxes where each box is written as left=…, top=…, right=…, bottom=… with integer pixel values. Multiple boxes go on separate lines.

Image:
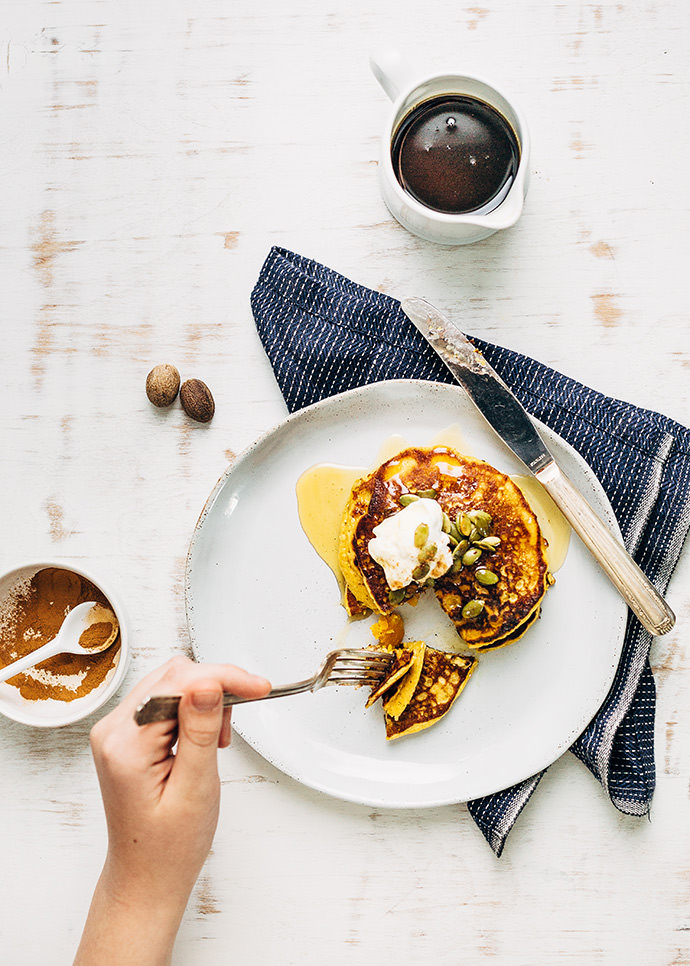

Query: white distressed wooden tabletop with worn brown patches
left=0, top=0, right=690, bottom=966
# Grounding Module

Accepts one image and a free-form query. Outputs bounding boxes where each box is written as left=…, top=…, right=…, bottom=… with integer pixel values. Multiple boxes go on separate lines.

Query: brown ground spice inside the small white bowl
left=0, top=567, right=120, bottom=701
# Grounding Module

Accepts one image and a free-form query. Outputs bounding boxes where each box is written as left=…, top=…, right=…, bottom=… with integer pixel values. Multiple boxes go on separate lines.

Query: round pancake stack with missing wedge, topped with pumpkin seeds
left=339, top=446, right=552, bottom=650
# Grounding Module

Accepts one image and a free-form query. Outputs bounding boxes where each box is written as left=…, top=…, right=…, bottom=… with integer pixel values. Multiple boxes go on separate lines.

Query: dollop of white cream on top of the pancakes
left=369, top=498, right=453, bottom=590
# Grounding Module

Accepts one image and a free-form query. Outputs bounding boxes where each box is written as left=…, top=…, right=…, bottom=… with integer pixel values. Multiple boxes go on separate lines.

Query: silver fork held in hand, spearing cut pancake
left=134, top=647, right=393, bottom=725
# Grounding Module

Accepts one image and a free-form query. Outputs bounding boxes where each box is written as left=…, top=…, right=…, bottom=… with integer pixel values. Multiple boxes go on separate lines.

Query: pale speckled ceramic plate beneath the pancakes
left=186, top=380, right=627, bottom=807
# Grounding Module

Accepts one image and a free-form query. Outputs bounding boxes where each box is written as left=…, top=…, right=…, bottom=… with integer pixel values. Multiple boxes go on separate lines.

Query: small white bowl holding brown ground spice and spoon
left=0, top=560, right=130, bottom=728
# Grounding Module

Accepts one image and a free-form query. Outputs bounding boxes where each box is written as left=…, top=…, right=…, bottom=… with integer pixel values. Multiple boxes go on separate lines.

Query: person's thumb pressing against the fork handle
left=172, top=678, right=223, bottom=788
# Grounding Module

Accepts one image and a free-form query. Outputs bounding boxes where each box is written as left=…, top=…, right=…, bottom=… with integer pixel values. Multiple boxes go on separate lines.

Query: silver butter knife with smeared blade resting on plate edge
left=401, top=298, right=676, bottom=634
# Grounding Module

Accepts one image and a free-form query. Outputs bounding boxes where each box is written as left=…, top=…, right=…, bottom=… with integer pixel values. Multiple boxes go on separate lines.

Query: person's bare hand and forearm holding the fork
left=76, top=657, right=270, bottom=966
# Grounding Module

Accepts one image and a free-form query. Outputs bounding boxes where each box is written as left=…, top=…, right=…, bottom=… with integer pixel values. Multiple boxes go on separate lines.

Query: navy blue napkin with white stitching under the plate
left=251, top=248, right=690, bottom=855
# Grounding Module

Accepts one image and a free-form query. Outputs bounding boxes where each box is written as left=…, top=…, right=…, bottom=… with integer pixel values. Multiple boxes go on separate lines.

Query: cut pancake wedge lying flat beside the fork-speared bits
left=385, top=647, right=477, bottom=741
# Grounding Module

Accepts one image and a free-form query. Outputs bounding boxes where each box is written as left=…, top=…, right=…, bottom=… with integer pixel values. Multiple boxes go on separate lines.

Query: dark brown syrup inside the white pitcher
left=391, top=94, right=520, bottom=215
